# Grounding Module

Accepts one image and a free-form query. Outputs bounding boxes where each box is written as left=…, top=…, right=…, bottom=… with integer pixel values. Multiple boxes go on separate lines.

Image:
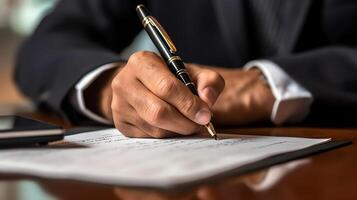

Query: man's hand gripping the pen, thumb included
left=93, top=52, right=224, bottom=138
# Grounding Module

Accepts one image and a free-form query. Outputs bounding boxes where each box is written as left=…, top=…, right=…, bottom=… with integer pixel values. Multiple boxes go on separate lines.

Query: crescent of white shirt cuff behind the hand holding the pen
left=75, top=63, right=118, bottom=124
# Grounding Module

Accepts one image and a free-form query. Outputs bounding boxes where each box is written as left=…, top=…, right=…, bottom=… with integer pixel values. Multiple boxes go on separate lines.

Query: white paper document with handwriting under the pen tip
left=0, top=129, right=329, bottom=187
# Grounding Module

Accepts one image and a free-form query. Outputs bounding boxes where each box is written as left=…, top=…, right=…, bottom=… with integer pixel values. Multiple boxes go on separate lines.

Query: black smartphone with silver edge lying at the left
left=0, top=116, right=64, bottom=148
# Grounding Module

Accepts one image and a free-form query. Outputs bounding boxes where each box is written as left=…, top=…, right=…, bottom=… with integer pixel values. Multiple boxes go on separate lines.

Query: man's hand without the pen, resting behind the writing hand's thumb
left=207, top=68, right=275, bottom=125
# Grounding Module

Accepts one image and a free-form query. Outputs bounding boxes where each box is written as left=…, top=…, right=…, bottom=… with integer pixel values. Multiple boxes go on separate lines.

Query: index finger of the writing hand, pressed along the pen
left=128, top=53, right=211, bottom=125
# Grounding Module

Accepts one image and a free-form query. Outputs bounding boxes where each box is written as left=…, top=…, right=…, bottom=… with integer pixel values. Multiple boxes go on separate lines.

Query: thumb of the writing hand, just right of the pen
left=187, top=64, right=225, bottom=107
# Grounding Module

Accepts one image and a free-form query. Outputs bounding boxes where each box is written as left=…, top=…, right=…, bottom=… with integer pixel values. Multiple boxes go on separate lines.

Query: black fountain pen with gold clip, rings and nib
left=136, top=4, right=217, bottom=140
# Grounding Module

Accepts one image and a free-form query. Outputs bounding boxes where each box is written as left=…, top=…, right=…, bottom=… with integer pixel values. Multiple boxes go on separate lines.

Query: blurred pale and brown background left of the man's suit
left=0, top=0, right=57, bottom=115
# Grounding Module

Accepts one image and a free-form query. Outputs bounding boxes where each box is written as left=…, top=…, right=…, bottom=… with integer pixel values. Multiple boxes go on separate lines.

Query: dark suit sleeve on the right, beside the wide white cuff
left=272, top=46, right=357, bottom=125
